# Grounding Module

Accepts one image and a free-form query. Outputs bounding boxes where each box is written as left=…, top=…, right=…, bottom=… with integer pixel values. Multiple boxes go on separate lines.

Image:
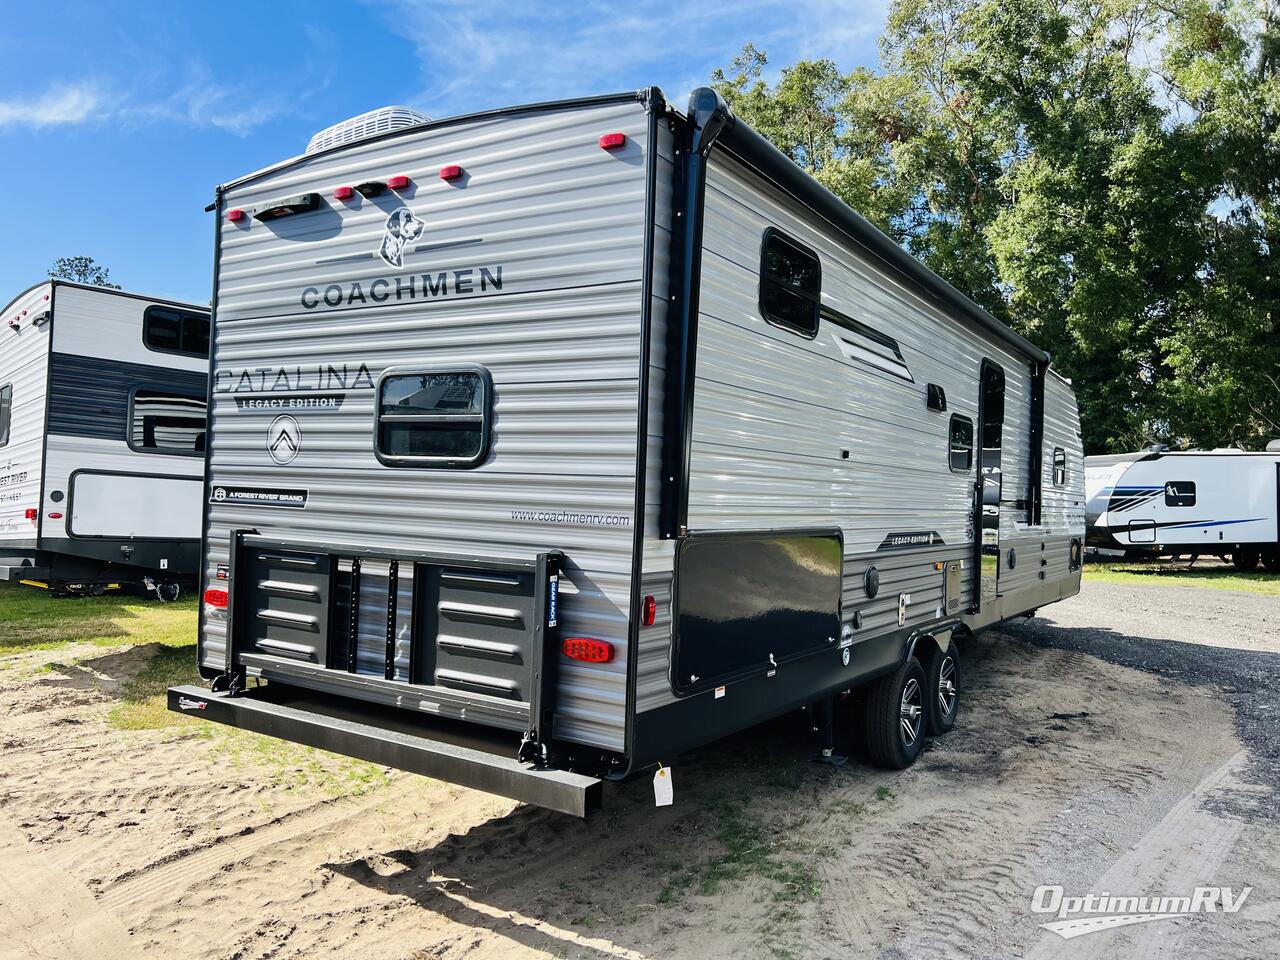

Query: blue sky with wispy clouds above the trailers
left=0, top=0, right=886, bottom=302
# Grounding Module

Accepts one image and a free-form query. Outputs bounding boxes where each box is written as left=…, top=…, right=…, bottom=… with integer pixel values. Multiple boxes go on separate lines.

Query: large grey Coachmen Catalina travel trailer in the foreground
left=169, top=88, right=1084, bottom=814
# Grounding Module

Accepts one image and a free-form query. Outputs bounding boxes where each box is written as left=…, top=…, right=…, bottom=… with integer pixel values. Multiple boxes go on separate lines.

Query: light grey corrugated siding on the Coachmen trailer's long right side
left=637, top=154, right=1070, bottom=709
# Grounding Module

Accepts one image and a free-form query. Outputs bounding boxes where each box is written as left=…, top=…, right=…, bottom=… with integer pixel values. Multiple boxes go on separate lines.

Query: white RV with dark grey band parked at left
left=0, top=280, right=209, bottom=599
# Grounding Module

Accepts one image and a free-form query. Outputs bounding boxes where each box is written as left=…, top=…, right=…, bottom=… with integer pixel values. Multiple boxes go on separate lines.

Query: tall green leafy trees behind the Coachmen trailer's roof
left=712, top=0, right=1280, bottom=453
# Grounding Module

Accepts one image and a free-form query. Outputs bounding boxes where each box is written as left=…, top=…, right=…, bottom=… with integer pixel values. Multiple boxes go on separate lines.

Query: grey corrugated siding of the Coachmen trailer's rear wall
left=201, top=104, right=649, bottom=750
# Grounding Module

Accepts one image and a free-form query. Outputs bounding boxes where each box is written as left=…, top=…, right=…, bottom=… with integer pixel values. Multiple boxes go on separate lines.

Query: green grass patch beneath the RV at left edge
left=0, top=584, right=197, bottom=660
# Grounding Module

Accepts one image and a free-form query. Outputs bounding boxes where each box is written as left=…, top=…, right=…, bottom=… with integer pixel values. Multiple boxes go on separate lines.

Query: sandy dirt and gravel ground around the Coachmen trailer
left=0, top=586, right=1280, bottom=960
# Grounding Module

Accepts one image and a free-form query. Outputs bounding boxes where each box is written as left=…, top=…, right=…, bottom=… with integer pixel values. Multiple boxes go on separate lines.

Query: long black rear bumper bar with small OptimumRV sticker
left=169, top=684, right=603, bottom=817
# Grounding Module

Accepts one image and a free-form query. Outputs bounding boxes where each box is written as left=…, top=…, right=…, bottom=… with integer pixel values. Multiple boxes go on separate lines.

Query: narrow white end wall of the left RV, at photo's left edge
left=0, top=283, right=51, bottom=549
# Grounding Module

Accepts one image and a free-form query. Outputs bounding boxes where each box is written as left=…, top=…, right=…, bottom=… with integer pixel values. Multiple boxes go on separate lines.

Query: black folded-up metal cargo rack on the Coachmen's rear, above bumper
left=233, top=535, right=559, bottom=732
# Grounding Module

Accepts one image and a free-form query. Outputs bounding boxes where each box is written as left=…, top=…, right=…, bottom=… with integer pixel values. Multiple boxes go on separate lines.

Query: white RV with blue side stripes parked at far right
left=1084, top=443, right=1280, bottom=572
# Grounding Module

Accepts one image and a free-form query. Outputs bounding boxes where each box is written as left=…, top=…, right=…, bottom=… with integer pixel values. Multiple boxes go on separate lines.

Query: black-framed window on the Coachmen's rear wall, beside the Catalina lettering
left=374, top=367, right=493, bottom=467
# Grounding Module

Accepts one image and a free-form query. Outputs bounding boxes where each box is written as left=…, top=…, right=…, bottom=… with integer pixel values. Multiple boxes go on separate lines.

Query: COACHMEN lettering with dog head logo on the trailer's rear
left=300, top=206, right=502, bottom=310
